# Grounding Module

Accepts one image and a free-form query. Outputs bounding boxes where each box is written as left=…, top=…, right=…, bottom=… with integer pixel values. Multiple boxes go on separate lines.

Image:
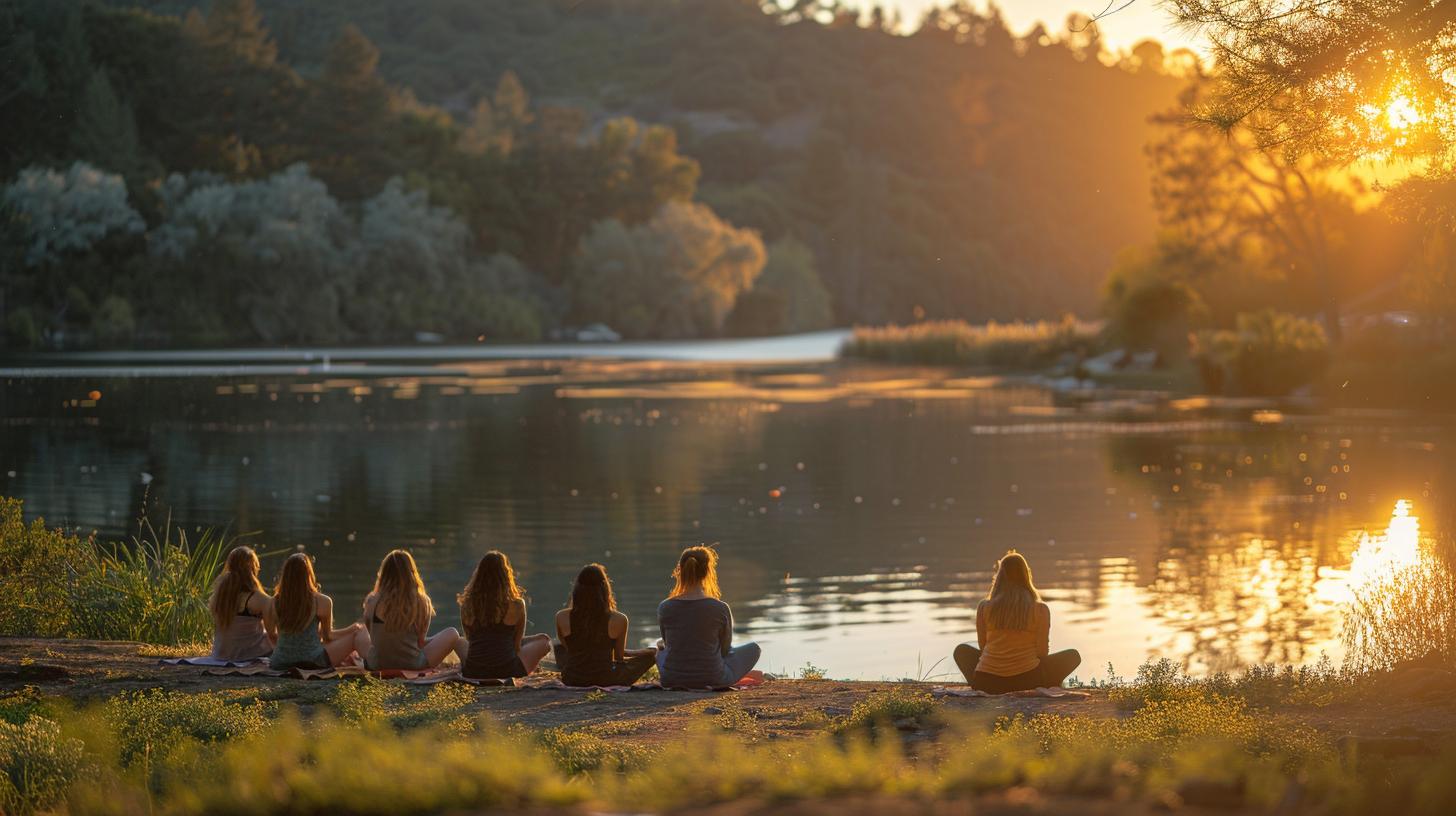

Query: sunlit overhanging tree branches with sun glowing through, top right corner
left=1168, top=0, right=1456, bottom=163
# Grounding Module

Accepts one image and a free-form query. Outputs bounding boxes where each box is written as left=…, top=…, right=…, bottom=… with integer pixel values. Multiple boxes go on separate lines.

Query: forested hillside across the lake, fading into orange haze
left=0, top=0, right=1198, bottom=348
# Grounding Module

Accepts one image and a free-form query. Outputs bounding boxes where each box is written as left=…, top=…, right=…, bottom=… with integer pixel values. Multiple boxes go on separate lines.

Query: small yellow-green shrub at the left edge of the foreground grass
left=0, top=717, right=84, bottom=815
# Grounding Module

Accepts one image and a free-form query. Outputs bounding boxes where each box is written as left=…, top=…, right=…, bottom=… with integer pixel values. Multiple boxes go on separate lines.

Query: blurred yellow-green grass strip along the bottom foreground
left=0, top=681, right=1456, bottom=816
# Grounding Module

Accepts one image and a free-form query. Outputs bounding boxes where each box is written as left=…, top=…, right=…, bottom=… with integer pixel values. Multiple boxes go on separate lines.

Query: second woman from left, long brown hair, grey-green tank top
left=265, top=552, right=368, bottom=669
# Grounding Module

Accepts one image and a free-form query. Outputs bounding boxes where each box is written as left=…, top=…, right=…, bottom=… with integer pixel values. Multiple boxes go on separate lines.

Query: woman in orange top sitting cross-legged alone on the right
left=955, top=549, right=1082, bottom=694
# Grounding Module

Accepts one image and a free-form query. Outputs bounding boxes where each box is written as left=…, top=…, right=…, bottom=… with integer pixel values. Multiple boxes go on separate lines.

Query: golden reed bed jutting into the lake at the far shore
left=839, top=316, right=1101, bottom=370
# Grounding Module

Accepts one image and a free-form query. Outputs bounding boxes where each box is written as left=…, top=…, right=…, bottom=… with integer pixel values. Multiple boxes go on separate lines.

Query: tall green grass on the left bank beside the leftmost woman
left=0, top=498, right=236, bottom=644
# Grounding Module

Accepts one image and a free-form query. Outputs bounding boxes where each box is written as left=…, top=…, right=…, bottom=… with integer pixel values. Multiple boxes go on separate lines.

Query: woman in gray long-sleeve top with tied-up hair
left=657, top=546, right=760, bottom=688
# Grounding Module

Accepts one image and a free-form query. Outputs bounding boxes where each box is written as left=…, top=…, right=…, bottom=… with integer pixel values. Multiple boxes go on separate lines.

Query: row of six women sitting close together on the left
left=211, top=546, right=760, bottom=688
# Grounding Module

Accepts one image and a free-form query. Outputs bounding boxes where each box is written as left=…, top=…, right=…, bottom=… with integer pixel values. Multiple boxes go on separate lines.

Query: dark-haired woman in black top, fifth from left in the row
left=556, top=564, right=657, bottom=686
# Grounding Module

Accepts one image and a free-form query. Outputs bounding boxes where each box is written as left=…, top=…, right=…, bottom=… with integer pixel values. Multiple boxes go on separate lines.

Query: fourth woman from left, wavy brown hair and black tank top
left=456, top=549, right=550, bottom=680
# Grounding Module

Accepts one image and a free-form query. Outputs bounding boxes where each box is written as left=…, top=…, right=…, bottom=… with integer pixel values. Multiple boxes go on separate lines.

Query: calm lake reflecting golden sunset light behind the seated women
left=0, top=335, right=1452, bottom=679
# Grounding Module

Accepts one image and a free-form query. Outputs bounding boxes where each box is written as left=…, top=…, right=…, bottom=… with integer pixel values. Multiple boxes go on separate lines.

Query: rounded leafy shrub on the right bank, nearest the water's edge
left=1192, top=309, right=1329, bottom=395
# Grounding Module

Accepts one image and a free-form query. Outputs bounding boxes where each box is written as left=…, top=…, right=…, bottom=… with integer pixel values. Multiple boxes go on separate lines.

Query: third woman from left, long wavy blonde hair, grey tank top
left=364, top=549, right=469, bottom=672
